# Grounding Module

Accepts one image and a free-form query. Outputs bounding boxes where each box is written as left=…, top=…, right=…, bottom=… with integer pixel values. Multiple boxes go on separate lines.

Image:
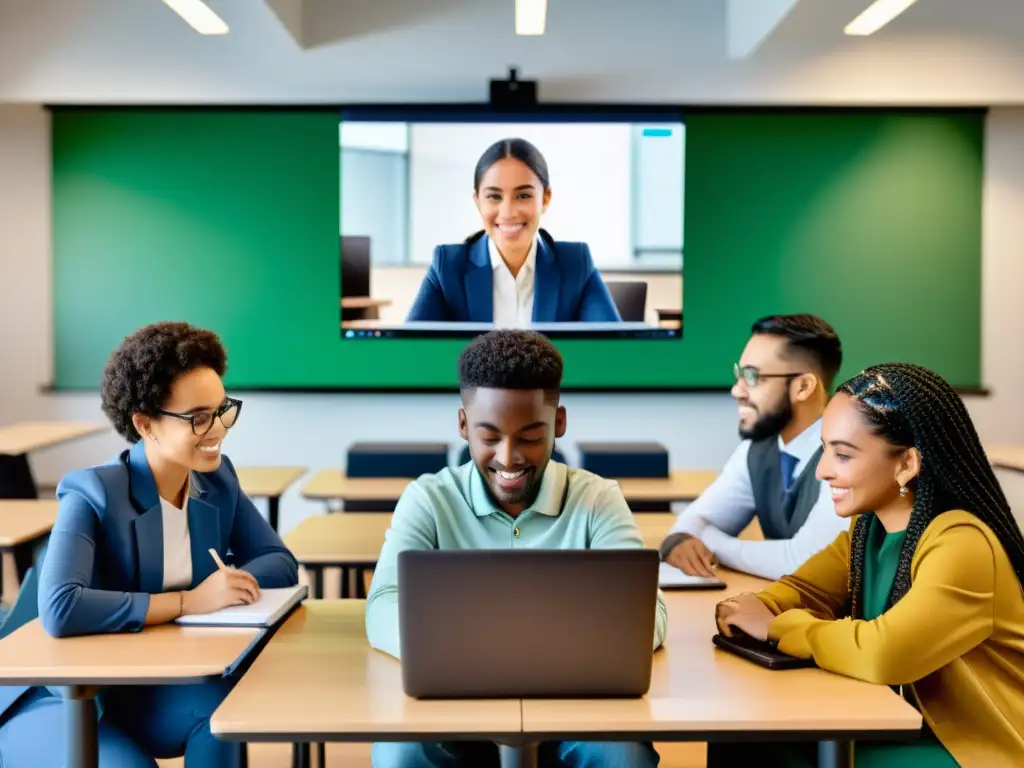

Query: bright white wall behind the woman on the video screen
left=409, top=123, right=633, bottom=268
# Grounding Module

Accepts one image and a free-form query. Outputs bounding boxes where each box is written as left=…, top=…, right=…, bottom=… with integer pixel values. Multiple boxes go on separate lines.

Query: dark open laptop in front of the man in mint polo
left=398, top=549, right=658, bottom=698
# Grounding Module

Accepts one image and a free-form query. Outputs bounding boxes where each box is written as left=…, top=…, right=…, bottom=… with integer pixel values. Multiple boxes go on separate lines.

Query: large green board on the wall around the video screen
left=52, top=109, right=984, bottom=390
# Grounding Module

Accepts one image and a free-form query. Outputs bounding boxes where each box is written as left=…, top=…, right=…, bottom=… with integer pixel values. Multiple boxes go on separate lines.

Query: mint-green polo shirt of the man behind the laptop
left=367, top=461, right=669, bottom=657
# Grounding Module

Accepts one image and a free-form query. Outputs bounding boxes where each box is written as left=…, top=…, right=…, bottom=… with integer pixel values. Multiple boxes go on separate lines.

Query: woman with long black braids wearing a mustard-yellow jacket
left=709, top=364, right=1024, bottom=768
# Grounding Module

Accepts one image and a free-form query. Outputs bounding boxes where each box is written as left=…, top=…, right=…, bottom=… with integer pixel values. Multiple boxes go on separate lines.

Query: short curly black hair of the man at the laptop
left=459, top=330, right=563, bottom=400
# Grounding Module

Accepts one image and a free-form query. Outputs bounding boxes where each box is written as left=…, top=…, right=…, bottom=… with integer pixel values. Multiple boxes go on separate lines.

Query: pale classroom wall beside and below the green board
left=0, top=105, right=1024, bottom=530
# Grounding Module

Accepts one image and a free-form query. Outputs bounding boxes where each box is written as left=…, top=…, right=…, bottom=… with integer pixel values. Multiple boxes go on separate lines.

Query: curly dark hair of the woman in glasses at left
left=100, top=323, right=227, bottom=442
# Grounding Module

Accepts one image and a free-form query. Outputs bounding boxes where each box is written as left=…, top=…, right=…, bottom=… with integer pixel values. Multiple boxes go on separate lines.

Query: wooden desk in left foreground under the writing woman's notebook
left=0, top=620, right=262, bottom=768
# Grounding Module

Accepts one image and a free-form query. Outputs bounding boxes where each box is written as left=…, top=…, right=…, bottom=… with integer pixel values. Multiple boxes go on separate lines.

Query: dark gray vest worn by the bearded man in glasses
left=746, top=437, right=821, bottom=539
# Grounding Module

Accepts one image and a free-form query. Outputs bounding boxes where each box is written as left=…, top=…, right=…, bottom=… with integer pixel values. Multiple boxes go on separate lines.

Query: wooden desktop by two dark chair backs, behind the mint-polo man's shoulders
left=302, top=469, right=718, bottom=512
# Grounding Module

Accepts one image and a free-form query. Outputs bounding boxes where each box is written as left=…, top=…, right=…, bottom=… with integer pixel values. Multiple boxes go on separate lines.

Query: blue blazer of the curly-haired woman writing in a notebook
left=0, top=442, right=299, bottom=713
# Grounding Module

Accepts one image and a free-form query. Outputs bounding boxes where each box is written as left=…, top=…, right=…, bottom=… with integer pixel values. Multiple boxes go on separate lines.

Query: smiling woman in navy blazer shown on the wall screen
left=407, top=138, right=622, bottom=328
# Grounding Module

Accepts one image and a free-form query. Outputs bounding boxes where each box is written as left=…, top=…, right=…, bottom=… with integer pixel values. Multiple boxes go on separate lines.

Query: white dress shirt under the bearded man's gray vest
left=670, top=419, right=850, bottom=580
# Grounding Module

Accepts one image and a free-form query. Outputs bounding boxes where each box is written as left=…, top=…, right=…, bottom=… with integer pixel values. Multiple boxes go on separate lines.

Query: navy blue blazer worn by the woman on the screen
left=406, top=237, right=622, bottom=323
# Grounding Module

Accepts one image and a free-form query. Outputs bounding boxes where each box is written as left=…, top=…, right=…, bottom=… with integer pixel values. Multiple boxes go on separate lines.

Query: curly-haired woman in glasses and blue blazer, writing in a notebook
left=0, top=323, right=298, bottom=768
